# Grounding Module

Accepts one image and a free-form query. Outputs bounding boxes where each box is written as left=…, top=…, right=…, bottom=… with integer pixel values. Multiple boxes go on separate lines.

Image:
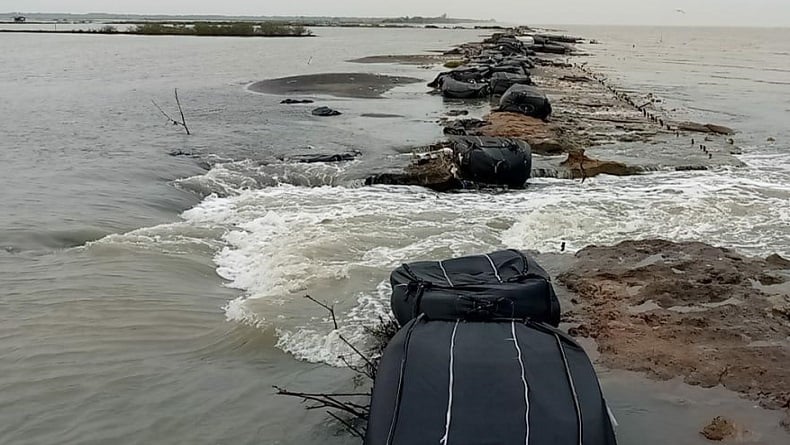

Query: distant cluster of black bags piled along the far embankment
left=428, top=35, right=552, bottom=119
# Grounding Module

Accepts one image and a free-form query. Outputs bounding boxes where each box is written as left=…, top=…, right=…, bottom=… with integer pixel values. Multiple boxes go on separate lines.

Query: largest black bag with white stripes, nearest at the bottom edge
left=364, top=319, right=616, bottom=445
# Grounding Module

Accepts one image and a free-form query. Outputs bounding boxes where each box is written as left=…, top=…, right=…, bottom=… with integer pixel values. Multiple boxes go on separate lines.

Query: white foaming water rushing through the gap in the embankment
left=173, top=160, right=790, bottom=365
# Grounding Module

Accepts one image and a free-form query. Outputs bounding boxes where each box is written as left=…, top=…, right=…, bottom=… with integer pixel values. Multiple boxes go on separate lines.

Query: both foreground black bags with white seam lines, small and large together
left=365, top=250, right=616, bottom=445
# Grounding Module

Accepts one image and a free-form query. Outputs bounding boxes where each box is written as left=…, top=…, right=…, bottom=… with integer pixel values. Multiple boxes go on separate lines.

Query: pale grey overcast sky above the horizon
left=0, top=0, right=790, bottom=26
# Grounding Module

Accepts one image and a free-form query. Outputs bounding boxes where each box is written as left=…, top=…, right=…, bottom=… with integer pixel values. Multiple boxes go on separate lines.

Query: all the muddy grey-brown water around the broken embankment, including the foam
left=0, top=28, right=790, bottom=444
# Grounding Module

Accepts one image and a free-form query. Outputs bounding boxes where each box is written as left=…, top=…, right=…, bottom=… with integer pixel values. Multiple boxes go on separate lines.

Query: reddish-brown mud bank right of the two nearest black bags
left=558, top=240, right=790, bottom=409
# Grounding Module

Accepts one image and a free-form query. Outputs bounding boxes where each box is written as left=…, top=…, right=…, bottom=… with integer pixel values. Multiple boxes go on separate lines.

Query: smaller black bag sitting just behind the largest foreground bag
left=390, top=250, right=560, bottom=326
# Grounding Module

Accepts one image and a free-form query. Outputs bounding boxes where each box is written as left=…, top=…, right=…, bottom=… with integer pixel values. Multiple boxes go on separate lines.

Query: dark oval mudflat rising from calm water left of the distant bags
left=248, top=73, right=421, bottom=99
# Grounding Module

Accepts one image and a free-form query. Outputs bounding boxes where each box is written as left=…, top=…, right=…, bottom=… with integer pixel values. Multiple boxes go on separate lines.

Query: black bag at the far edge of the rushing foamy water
left=452, top=136, right=532, bottom=188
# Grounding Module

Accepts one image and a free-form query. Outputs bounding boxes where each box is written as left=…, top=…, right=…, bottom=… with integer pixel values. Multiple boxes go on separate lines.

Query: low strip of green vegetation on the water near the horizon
left=131, top=22, right=312, bottom=37
